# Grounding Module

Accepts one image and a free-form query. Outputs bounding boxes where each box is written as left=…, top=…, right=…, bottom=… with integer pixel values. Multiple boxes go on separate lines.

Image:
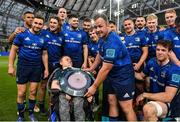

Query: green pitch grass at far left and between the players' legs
left=0, top=56, right=102, bottom=121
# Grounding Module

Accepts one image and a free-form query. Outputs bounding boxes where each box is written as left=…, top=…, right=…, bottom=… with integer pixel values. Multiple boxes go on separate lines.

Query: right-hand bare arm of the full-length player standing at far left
left=42, top=50, right=49, bottom=78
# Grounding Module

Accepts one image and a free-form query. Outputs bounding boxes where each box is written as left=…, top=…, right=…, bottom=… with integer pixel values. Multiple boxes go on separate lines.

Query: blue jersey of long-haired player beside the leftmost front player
left=42, top=30, right=64, bottom=63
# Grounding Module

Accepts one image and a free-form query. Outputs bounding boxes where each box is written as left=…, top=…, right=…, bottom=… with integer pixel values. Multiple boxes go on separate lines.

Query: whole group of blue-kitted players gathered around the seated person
left=8, top=8, right=180, bottom=121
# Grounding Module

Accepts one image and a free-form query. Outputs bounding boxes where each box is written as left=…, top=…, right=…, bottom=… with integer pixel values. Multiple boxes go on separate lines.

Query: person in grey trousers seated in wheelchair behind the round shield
left=51, top=56, right=92, bottom=121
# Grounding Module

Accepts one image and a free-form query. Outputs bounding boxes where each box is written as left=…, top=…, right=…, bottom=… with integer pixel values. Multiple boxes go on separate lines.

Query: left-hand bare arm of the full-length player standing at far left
left=8, top=45, right=18, bottom=76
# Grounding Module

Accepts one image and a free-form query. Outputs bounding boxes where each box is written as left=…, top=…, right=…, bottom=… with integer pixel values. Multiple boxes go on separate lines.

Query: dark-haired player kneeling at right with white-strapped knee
left=136, top=40, right=180, bottom=121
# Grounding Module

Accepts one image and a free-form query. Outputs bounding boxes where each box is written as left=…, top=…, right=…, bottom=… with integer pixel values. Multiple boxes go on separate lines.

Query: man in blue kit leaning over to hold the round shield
left=85, top=14, right=136, bottom=121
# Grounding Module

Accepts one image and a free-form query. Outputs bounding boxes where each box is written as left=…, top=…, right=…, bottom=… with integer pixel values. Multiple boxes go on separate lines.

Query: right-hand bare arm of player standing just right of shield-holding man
left=134, top=46, right=148, bottom=71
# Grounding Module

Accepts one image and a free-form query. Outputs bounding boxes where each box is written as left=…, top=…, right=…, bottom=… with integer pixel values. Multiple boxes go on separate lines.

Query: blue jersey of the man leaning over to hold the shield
left=99, top=32, right=131, bottom=67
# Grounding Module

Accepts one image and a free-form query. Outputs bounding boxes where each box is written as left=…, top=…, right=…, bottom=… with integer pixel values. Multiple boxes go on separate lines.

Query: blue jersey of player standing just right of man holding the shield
left=124, top=32, right=148, bottom=63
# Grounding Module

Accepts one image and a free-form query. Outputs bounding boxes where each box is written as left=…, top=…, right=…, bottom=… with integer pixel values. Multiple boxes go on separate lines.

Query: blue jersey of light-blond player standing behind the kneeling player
left=146, top=30, right=163, bottom=59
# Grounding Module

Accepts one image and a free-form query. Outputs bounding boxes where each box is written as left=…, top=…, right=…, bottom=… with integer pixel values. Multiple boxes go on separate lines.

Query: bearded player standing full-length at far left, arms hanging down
left=8, top=16, right=48, bottom=121
